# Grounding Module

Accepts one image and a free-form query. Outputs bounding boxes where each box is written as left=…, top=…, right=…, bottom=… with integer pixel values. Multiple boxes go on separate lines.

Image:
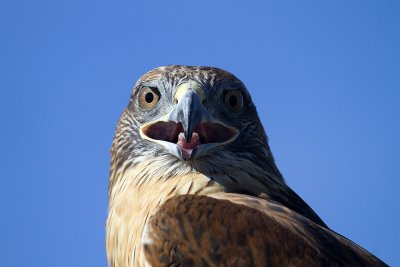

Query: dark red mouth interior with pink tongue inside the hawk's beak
left=142, top=121, right=237, bottom=160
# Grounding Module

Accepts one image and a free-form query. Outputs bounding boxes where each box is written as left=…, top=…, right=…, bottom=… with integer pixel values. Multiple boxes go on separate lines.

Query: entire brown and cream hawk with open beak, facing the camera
left=106, top=65, right=387, bottom=267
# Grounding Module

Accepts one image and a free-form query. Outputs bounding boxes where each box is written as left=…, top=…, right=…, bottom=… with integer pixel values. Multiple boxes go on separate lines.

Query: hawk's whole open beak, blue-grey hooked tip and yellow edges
left=140, top=89, right=239, bottom=160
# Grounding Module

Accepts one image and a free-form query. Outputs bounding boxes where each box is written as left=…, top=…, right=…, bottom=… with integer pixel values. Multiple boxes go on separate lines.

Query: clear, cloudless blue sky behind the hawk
left=0, top=0, right=400, bottom=266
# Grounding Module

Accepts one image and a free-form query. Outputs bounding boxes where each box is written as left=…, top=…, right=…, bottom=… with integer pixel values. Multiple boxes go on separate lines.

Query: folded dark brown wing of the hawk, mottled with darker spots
left=144, top=193, right=387, bottom=266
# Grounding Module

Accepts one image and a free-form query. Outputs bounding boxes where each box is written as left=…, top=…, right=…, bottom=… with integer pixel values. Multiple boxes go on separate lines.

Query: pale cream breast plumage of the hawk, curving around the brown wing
left=106, top=163, right=223, bottom=267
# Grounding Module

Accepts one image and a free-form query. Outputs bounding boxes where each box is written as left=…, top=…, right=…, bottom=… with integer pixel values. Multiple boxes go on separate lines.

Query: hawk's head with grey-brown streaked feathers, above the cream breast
left=111, top=66, right=281, bottom=193
